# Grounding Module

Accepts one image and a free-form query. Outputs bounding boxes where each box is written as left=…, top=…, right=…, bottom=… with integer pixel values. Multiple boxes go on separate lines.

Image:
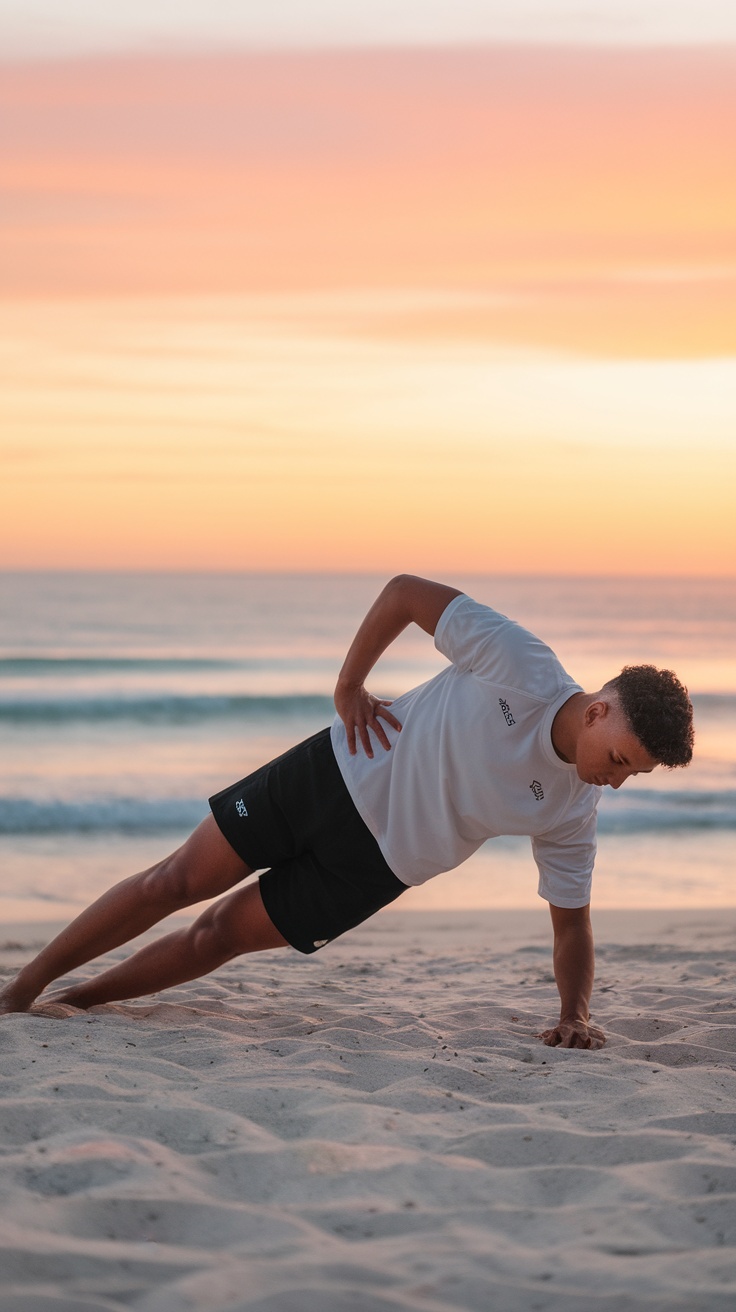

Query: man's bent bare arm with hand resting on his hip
left=335, top=575, right=460, bottom=757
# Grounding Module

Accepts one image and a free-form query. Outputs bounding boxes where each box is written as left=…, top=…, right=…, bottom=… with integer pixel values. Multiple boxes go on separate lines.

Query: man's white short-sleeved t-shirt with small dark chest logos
left=332, top=594, right=601, bottom=907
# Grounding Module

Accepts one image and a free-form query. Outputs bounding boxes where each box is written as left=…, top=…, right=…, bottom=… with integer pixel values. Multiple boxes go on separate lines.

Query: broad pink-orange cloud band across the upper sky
left=0, top=49, right=736, bottom=343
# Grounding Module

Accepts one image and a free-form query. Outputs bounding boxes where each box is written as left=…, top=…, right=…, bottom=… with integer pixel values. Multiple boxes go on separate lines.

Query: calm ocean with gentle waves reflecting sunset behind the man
left=0, top=573, right=736, bottom=925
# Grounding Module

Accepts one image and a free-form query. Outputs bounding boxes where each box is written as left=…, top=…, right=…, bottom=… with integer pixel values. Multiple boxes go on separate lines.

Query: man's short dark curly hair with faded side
left=606, top=665, right=695, bottom=769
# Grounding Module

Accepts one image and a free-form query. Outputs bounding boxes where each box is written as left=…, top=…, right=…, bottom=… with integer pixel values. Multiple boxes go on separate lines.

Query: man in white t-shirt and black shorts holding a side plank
left=0, top=575, right=693, bottom=1048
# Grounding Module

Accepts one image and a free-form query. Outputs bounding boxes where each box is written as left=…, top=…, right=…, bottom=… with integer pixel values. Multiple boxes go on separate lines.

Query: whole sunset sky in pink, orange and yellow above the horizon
left=0, top=0, right=736, bottom=575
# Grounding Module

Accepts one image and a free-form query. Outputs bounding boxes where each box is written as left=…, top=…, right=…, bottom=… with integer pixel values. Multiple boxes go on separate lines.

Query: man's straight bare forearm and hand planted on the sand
left=538, top=903, right=606, bottom=1048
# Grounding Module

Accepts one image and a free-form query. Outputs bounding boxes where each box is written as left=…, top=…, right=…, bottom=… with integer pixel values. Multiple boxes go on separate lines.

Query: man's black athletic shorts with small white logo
left=210, top=729, right=407, bottom=953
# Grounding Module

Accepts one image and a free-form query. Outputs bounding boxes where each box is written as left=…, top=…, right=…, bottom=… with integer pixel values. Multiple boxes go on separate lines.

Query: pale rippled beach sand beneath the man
left=0, top=908, right=736, bottom=1312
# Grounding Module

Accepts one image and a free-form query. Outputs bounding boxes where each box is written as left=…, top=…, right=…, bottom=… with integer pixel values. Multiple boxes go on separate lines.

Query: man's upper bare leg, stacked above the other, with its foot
left=0, top=816, right=263, bottom=1013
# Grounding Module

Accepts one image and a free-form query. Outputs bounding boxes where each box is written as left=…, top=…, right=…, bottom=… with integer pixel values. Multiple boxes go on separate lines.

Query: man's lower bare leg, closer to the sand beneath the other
left=49, top=884, right=289, bottom=1008
